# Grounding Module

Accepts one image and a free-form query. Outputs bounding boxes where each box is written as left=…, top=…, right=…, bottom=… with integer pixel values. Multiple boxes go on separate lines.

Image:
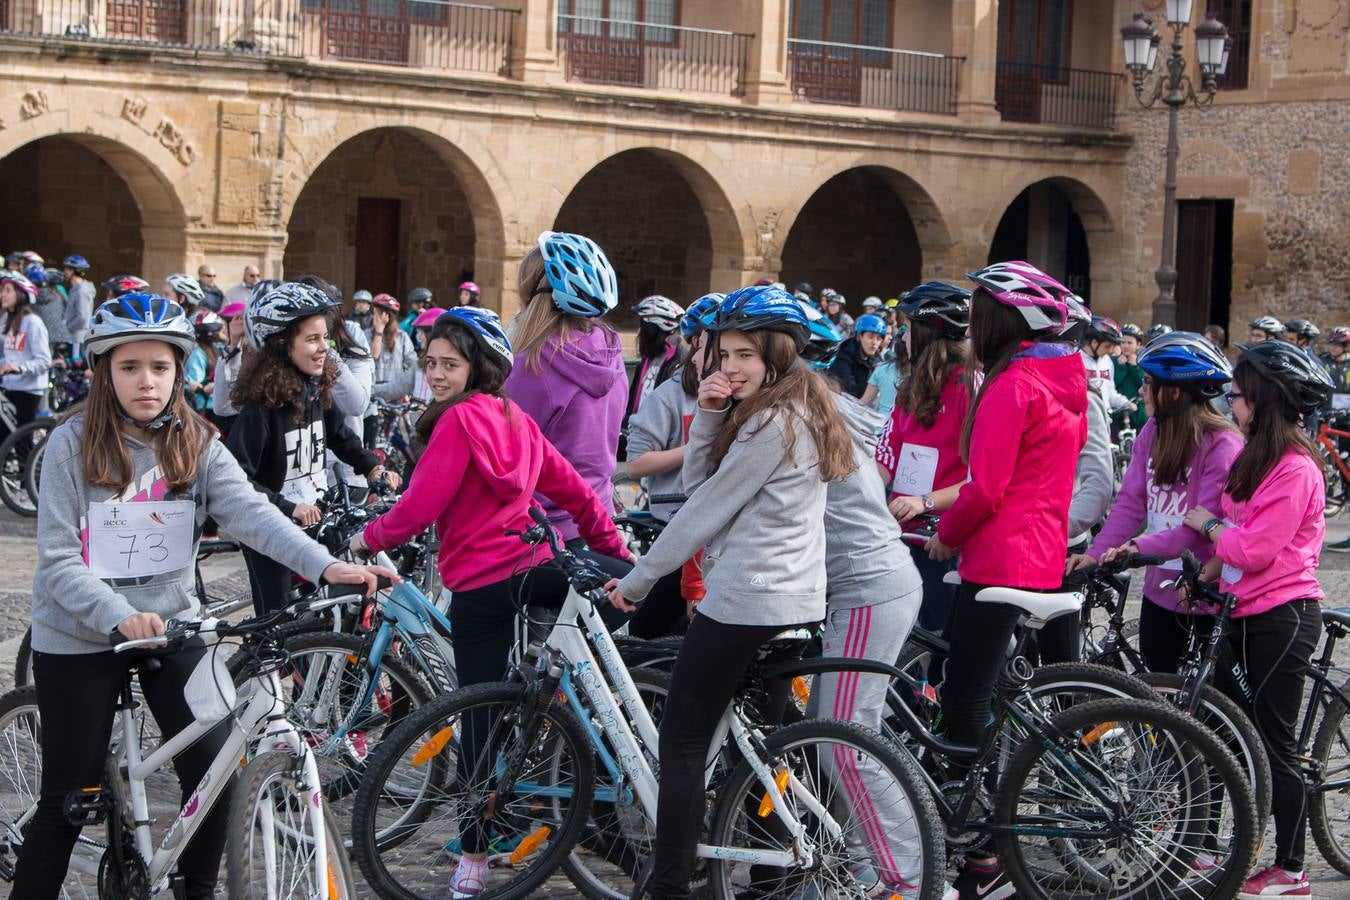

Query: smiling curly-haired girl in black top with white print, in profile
left=221, top=282, right=400, bottom=614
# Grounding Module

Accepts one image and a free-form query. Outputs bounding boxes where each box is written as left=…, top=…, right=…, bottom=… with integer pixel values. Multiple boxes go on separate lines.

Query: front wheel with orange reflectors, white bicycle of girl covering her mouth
left=352, top=681, right=594, bottom=900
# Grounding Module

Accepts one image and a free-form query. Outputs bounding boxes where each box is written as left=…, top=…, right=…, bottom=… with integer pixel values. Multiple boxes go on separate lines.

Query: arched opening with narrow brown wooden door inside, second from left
left=290, top=128, right=495, bottom=305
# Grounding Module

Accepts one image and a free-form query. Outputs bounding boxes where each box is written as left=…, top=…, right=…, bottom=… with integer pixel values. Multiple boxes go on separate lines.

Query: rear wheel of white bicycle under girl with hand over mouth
left=707, top=719, right=946, bottom=900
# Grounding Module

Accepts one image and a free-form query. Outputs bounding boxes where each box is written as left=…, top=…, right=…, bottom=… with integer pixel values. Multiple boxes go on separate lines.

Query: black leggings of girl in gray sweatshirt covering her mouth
left=647, top=615, right=791, bottom=900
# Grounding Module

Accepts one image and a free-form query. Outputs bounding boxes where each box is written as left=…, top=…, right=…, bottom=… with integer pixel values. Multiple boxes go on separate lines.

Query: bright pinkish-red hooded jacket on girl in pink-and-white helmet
left=937, top=344, right=1088, bottom=590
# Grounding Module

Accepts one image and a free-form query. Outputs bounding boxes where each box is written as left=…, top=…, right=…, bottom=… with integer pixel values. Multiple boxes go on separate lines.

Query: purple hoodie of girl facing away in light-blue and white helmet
left=506, top=324, right=628, bottom=541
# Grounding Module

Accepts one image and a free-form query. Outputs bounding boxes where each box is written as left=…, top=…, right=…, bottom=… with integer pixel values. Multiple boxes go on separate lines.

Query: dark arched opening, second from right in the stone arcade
left=780, top=166, right=932, bottom=307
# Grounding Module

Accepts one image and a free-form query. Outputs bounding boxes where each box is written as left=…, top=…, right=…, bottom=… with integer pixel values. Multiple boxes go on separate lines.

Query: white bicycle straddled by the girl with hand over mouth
left=352, top=511, right=945, bottom=900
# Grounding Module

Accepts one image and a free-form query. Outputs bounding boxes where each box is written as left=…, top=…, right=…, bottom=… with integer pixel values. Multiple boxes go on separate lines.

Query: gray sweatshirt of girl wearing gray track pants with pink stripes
left=825, top=394, right=923, bottom=609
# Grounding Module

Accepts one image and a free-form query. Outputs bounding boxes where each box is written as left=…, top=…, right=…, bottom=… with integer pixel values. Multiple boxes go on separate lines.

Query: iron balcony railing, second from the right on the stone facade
left=787, top=38, right=964, bottom=116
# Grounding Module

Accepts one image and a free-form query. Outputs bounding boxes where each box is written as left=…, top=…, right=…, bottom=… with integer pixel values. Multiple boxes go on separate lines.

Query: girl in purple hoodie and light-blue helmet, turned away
left=506, top=231, right=628, bottom=550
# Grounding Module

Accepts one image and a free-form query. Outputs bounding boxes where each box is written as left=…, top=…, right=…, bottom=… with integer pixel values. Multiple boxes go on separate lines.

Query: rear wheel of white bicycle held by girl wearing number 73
left=0, top=687, right=107, bottom=900
